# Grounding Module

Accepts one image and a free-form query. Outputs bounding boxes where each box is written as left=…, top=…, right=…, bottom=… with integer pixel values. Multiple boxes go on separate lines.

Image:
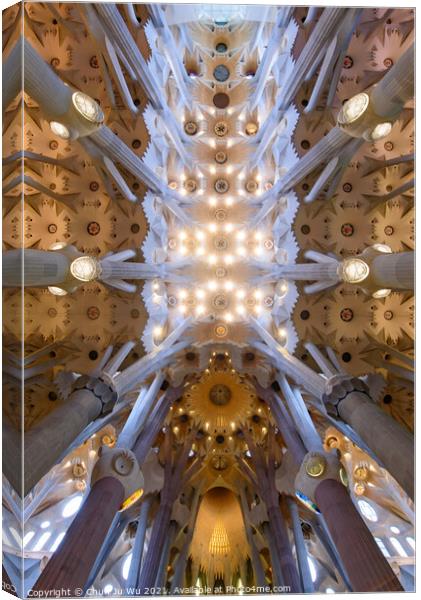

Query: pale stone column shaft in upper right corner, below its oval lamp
left=371, top=44, right=415, bottom=119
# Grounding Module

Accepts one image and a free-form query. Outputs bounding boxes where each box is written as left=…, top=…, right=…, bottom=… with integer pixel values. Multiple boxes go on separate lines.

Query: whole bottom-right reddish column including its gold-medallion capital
left=295, top=451, right=402, bottom=592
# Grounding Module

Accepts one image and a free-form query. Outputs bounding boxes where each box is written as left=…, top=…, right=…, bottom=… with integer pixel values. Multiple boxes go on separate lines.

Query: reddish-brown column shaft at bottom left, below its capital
left=33, top=477, right=124, bottom=596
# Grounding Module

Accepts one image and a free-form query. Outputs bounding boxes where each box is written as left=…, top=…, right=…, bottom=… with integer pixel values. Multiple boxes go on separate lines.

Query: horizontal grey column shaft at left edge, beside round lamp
left=3, top=248, right=70, bottom=287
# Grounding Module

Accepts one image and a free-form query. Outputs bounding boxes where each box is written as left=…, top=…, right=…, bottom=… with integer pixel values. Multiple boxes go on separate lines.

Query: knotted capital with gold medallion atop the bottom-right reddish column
left=295, top=451, right=346, bottom=507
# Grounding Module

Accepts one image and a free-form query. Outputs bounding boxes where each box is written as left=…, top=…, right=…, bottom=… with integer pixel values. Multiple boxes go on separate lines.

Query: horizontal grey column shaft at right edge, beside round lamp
left=370, top=252, right=415, bottom=290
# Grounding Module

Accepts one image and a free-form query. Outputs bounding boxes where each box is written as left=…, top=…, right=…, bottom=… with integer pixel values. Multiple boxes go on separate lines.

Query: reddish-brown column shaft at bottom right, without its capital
left=315, top=479, right=402, bottom=592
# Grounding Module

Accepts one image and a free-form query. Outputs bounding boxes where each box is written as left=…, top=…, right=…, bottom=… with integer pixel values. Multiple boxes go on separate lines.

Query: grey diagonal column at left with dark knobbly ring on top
left=24, top=376, right=117, bottom=495
